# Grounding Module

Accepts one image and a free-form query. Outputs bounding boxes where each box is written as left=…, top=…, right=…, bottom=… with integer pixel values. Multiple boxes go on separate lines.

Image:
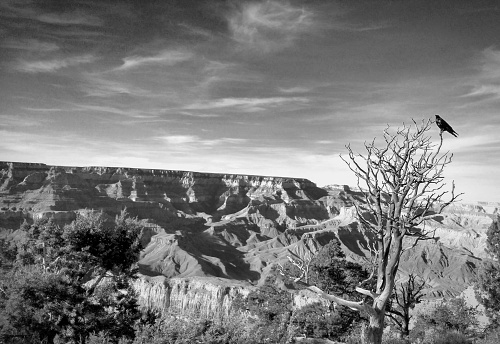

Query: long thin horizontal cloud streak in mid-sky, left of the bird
left=186, top=97, right=309, bottom=112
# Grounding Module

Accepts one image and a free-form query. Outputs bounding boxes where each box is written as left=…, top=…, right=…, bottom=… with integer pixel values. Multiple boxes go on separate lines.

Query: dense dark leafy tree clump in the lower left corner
left=0, top=212, right=146, bottom=343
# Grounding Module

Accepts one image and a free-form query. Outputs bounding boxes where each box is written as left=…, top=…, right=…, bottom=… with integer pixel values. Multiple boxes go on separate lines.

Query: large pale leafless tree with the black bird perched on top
left=300, top=119, right=461, bottom=344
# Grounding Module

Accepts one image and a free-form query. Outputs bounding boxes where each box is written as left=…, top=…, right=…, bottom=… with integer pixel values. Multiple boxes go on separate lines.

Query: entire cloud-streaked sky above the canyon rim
left=0, top=0, right=500, bottom=202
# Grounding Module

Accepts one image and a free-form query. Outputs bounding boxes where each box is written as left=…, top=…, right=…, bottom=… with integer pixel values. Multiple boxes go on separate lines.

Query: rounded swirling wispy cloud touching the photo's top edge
left=228, top=1, right=313, bottom=52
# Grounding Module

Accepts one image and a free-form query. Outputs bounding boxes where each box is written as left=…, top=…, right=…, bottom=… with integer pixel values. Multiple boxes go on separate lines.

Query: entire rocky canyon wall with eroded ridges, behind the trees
left=0, top=162, right=499, bottom=300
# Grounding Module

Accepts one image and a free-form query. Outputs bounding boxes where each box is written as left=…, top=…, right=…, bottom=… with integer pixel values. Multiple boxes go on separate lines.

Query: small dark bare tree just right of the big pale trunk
left=387, top=274, right=425, bottom=337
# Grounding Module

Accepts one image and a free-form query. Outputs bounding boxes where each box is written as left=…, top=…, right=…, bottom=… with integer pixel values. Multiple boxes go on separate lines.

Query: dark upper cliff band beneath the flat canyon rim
left=0, top=162, right=326, bottom=224
